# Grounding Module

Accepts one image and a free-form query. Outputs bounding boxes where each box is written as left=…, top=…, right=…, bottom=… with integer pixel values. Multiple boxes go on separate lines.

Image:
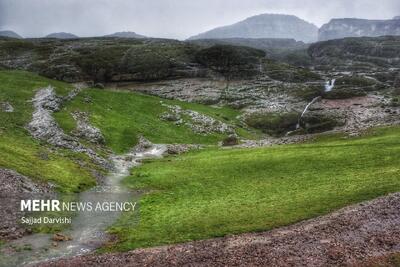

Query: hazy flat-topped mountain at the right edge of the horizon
left=318, top=17, right=400, bottom=41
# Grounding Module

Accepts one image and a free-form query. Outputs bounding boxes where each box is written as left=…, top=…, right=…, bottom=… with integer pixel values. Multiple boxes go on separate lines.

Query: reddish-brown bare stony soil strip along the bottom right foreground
left=39, top=193, right=400, bottom=266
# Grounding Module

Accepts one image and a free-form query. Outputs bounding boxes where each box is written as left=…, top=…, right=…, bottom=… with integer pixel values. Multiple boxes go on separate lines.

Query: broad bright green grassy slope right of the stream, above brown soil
left=105, top=128, right=400, bottom=250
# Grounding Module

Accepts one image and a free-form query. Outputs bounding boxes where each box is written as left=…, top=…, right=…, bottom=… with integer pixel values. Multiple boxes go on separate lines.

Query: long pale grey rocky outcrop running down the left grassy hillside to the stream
left=27, top=86, right=110, bottom=168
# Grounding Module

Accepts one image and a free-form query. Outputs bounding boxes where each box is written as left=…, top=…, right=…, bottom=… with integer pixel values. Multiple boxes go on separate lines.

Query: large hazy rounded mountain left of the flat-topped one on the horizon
left=189, top=14, right=318, bottom=43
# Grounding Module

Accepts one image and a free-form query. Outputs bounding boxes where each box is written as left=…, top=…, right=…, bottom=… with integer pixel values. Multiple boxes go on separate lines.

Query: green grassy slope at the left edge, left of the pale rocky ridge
left=0, top=71, right=95, bottom=192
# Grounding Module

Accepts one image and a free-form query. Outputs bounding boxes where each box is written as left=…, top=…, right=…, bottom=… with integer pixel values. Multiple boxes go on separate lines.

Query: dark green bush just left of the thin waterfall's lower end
left=245, top=112, right=299, bottom=135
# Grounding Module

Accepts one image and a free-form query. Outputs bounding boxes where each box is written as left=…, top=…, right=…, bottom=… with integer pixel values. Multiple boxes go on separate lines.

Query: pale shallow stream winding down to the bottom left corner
left=0, top=145, right=166, bottom=267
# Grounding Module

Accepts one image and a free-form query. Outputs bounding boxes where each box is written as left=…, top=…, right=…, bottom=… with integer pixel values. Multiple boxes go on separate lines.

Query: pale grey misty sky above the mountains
left=0, top=0, right=400, bottom=39
